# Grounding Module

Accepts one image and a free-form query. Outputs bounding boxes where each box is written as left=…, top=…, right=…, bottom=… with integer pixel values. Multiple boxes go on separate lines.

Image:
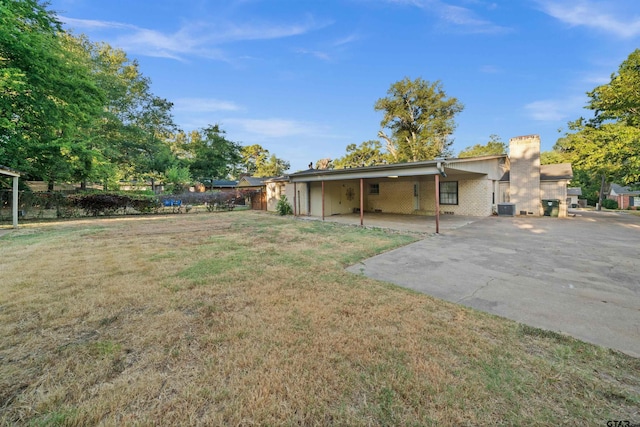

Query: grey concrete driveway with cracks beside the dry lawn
left=349, top=211, right=640, bottom=357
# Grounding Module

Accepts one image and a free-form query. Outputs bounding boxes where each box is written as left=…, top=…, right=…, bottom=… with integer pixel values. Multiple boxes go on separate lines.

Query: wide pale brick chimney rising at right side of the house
left=509, top=135, right=542, bottom=216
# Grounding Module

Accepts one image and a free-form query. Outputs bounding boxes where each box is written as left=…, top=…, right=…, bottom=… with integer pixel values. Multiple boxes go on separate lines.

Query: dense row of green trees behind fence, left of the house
left=0, top=0, right=289, bottom=189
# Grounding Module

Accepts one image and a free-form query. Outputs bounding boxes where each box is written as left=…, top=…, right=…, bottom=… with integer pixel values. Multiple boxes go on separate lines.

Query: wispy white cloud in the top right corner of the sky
left=538, top=0, right=640, bottom=38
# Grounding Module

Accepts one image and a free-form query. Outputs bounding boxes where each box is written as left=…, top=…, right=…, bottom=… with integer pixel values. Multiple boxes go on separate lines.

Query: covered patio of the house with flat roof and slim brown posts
left=287, top=155, right=508, bottom=233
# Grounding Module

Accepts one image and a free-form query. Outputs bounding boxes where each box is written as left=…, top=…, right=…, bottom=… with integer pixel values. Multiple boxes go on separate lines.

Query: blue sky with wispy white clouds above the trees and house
left=50, top=0, right=640, bottom=172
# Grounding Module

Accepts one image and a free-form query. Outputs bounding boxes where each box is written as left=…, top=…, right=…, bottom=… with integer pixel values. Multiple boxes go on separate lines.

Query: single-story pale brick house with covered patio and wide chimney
left=285, top=135, right=573, bottom=218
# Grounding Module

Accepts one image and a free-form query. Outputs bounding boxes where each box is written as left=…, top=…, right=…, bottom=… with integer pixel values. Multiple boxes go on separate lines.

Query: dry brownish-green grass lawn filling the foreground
left=0, top=212, right=640, bottom=426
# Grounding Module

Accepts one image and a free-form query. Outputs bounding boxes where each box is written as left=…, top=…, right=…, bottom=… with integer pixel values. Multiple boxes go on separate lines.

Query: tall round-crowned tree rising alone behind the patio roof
left=374, top=77, right=464, bottom=162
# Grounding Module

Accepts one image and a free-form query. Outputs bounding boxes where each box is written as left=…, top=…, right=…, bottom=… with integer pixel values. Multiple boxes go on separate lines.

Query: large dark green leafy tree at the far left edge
left=0, top=0, right=104, bottom=188
